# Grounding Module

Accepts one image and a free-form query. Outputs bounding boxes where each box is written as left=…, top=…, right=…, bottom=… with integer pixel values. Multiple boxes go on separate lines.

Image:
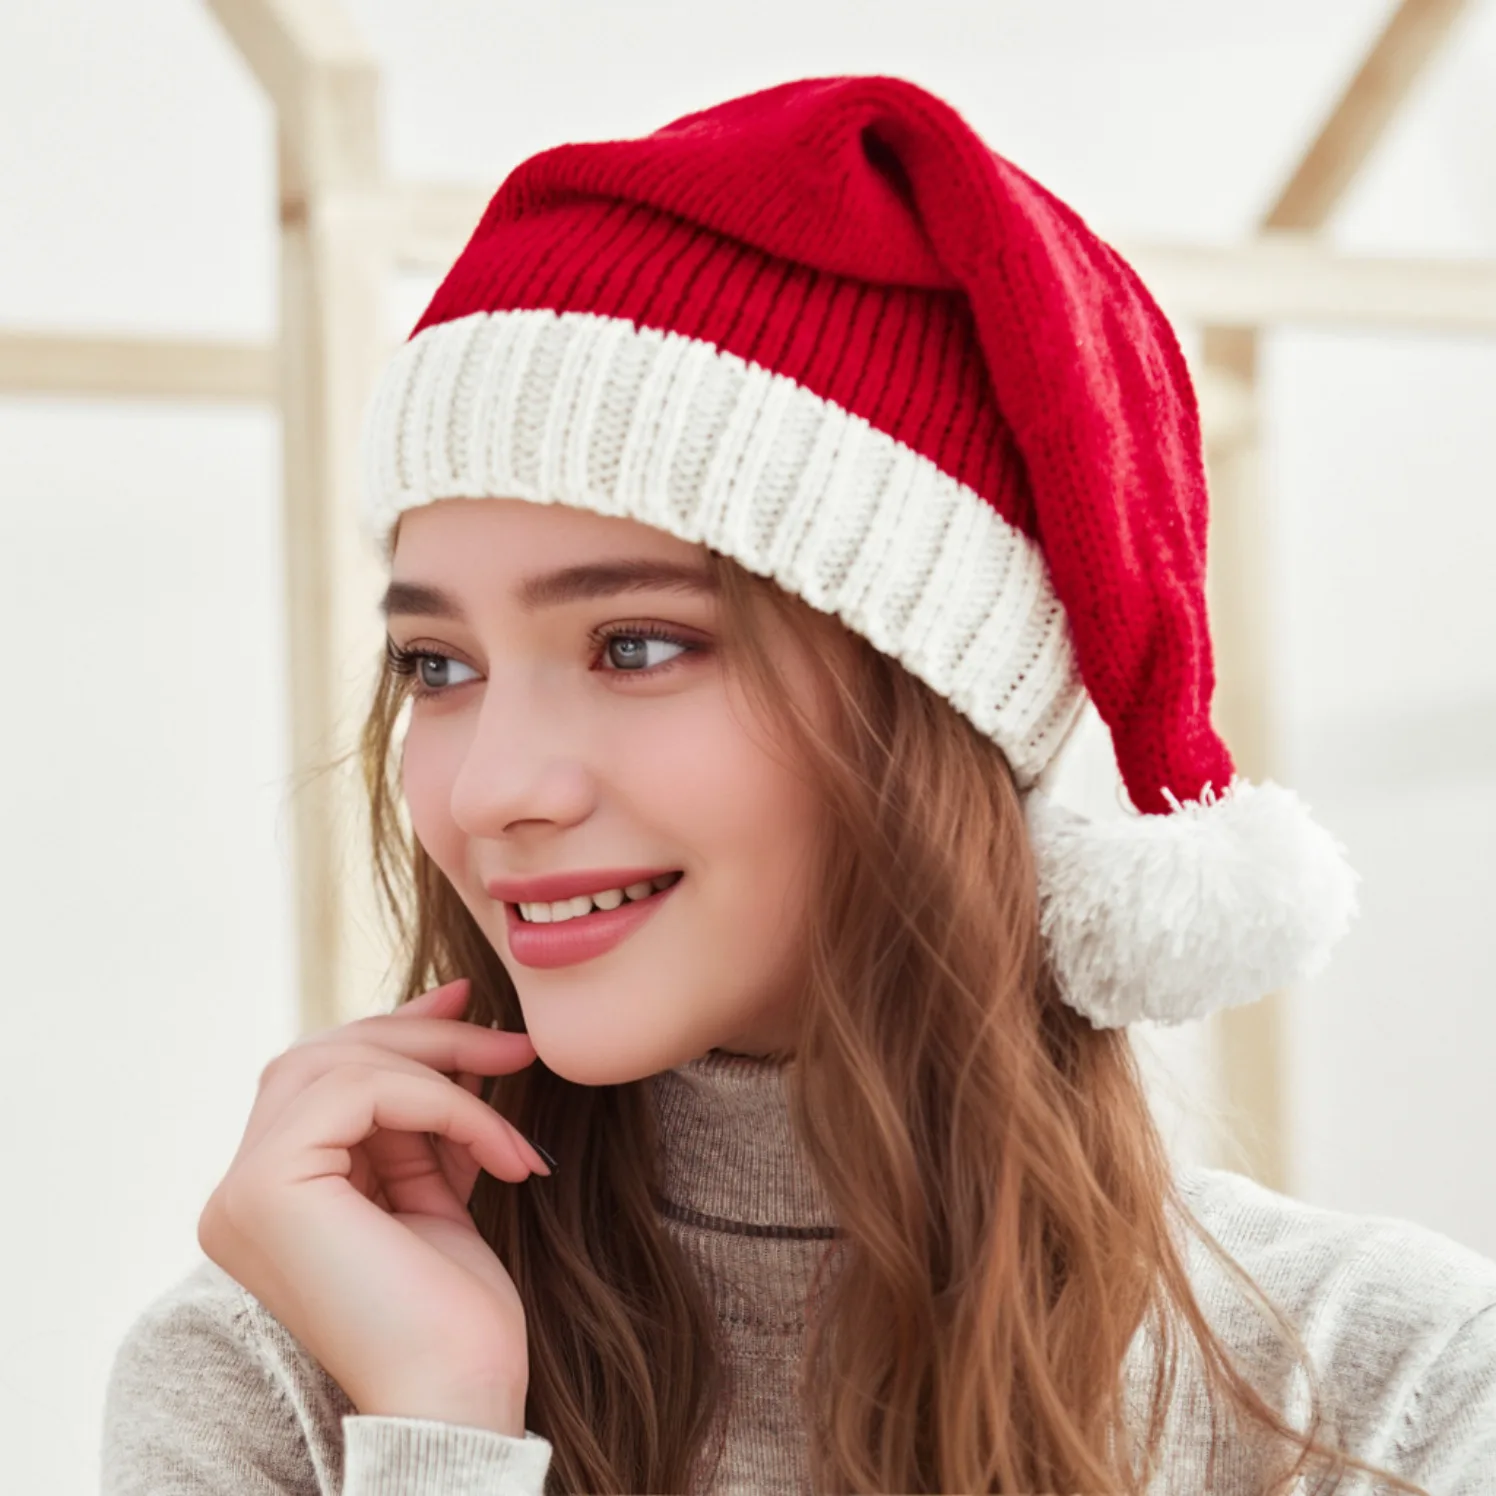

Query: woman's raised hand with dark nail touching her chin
left=197, top=978, right=551, bottom=1438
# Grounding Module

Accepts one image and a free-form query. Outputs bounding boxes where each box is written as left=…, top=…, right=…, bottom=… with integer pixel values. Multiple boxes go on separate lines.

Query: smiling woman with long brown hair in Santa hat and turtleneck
left=105, top=78, right=1496, bottom=1496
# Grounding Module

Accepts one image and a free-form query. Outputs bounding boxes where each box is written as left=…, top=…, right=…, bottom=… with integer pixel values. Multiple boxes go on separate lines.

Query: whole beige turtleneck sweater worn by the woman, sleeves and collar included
left=102, top=1052, right=1496, bottom=1496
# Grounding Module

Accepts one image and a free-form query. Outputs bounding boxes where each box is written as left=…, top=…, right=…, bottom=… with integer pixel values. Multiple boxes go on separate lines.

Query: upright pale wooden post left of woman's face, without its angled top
left=273, top=151, right=389, bottom=1032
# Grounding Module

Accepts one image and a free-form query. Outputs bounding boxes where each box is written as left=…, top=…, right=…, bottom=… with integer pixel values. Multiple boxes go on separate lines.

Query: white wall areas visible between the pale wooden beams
left=0, top=0, right=1496, bottom=1493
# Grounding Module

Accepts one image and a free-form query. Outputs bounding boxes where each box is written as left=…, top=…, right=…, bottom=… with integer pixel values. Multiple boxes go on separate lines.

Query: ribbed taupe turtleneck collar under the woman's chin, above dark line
left=651, top=1049, right=836, bottom=1237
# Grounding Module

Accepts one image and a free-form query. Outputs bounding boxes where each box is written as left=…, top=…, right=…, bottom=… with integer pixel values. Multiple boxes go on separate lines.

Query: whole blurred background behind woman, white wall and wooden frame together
left=0, top=0, right=1496, bottom=1493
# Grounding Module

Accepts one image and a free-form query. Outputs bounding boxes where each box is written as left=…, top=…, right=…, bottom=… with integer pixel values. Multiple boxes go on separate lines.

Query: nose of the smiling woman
left=452, top=673, right=597, bottom=841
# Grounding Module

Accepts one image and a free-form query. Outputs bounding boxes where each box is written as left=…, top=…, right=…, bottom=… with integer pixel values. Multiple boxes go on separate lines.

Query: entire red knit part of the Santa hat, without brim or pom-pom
left=413, top=78, right=1233, bottom=812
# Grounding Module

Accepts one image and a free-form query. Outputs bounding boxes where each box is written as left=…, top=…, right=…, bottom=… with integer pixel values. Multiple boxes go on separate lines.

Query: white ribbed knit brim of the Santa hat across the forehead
left=364, top=311, right=1086, bottom=788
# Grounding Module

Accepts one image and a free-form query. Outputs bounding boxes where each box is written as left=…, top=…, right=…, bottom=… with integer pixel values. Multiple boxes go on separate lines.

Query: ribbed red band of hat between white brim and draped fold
left=413, top=195, right=1034, bottom=536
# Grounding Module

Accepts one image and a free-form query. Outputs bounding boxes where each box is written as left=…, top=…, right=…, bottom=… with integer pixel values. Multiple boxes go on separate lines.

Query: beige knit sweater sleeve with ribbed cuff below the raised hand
left=100, top=1264, right=551, bottom=1496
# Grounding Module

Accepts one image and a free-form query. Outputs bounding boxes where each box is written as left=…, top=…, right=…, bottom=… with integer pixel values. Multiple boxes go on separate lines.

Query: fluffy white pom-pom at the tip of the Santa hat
left=1026, top=778, right=1358, bottom=1028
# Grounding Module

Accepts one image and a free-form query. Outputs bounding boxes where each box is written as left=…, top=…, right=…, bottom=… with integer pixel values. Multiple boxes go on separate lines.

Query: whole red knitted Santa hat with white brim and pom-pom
left=365, top=78, right=1355, bottom=1026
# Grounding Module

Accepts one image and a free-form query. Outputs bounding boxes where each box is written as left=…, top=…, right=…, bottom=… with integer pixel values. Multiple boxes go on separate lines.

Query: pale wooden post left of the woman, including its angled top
left=208, top=0, right=390, bottom=1032
